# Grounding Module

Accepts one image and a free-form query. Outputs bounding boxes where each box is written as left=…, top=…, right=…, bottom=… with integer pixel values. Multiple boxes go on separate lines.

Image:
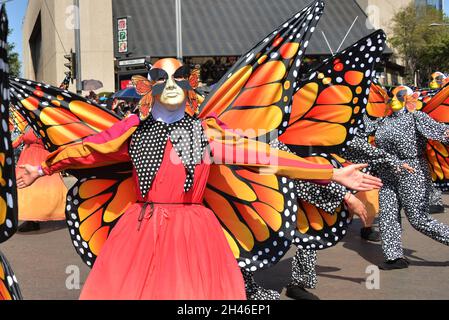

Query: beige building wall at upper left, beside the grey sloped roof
left=22, top=0, right=115, bottom=92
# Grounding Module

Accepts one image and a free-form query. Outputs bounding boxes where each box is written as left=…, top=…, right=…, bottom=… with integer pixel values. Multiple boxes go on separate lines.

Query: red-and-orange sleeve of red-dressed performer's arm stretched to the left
left=42, top=116, right=140, bottom=175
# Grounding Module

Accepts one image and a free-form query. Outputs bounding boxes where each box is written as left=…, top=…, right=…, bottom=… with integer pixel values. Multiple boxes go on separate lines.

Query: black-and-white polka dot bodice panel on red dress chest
left=129, top=115, right=208, bottom=197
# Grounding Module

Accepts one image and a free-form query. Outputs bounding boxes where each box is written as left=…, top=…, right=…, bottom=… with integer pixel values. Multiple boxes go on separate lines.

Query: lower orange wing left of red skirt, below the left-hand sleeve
left=66, top=163, right=137, bottom=267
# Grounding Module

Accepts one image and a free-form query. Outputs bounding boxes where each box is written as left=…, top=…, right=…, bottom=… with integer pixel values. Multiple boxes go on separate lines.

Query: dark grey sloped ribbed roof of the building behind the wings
left=112, top=0, right=392, bottom=57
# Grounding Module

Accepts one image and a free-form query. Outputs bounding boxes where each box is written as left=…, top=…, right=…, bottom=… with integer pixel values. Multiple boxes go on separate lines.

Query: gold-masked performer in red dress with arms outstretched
left=17, top=59, right=381, bottom=300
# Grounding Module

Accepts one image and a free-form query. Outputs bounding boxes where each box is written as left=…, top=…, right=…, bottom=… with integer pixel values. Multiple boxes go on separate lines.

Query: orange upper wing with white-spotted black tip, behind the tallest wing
left=279, top=30, right=386, bottom=156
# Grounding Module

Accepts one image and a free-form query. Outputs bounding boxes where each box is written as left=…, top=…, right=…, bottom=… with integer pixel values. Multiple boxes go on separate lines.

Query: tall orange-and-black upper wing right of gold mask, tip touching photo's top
left=199, top=1, right=324, bottom=138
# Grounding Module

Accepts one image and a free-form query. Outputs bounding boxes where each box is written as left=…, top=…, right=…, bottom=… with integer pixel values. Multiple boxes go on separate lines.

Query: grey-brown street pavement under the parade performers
left=0, top=179, right=449, bottom=300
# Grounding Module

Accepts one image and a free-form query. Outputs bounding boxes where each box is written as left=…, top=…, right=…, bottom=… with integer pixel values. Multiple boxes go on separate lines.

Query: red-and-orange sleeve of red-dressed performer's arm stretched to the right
left=203, top=118, right=334, bottom=184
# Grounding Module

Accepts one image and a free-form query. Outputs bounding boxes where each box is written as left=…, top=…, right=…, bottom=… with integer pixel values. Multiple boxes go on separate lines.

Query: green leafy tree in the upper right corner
left=390, top=2, right=449, bottom=85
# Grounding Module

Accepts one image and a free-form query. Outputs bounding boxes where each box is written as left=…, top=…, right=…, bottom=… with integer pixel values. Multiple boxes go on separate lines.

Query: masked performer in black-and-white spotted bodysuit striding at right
left=369, top=87, right=449, bottom=270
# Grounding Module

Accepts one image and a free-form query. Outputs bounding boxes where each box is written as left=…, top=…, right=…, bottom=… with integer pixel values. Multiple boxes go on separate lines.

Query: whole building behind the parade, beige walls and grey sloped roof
left=23, top=0, right=396, bottom=91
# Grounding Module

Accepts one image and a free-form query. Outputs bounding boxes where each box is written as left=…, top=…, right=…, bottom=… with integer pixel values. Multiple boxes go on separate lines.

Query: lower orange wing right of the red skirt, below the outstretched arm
left=204, top=165, right=298, bottom=271
